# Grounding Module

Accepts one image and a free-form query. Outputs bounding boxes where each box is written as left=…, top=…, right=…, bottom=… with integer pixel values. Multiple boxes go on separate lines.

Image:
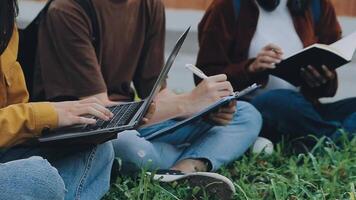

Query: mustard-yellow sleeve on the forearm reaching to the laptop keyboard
left=0, top=103, right=58, bottom=148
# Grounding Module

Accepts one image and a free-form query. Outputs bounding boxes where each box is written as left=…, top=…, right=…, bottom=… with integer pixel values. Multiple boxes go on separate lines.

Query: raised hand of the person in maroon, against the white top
left=247, top=44, right=283, bottom=73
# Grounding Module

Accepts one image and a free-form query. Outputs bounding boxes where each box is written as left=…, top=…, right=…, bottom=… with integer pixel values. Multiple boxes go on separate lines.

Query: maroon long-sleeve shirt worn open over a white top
left=196, top=0, right=341, bottom=101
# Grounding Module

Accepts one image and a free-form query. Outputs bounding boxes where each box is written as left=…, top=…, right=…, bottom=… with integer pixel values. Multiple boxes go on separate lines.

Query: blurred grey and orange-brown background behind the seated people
left=18, top=0, right=356, bottom=101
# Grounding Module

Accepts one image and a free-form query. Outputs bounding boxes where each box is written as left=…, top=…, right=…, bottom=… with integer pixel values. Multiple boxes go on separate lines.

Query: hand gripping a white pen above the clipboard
left=187, top=74, right=233, bottom=116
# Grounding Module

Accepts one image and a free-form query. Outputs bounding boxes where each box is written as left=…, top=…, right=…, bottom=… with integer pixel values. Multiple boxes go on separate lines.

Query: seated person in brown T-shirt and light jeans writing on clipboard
left=34, top=0, right=262, bottom=195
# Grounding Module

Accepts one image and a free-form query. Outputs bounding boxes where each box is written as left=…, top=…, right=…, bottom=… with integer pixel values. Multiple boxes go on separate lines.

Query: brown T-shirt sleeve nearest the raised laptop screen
left=133, top=1, right=166, bottom=98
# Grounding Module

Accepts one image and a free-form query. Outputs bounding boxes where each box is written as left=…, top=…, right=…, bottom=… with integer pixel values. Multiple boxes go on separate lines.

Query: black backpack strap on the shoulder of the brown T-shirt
left=75, top=0, right=100, bottom=58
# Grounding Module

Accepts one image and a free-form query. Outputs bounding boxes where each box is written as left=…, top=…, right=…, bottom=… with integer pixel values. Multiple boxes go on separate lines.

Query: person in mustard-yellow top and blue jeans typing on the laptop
left=0, top=0, right=114, bottom=200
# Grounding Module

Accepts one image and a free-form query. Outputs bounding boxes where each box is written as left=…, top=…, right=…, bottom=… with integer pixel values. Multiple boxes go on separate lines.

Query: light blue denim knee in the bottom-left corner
left=0, top=157, right=65, bottom=200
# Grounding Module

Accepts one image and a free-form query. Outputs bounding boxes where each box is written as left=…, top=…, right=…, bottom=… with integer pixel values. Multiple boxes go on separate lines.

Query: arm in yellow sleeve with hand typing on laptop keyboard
left=0, top=98, right=113, bottom=148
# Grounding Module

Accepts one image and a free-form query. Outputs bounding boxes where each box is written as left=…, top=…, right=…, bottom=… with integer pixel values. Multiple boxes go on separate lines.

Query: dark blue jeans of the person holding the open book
left=252, top=90, right=356, bottom=139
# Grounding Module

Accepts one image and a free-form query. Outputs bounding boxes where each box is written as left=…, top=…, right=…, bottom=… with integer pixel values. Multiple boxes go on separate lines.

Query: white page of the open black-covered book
left=330, top=32, right=356, bottom=61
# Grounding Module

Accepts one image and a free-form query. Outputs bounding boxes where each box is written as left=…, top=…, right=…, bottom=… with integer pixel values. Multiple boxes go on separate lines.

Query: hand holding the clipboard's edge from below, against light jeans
left=209, top=100, right=236, bottom=126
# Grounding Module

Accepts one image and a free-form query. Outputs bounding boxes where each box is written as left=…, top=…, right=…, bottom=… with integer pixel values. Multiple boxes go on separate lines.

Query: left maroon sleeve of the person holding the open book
left=196, top=5, right=268, bottom=90
